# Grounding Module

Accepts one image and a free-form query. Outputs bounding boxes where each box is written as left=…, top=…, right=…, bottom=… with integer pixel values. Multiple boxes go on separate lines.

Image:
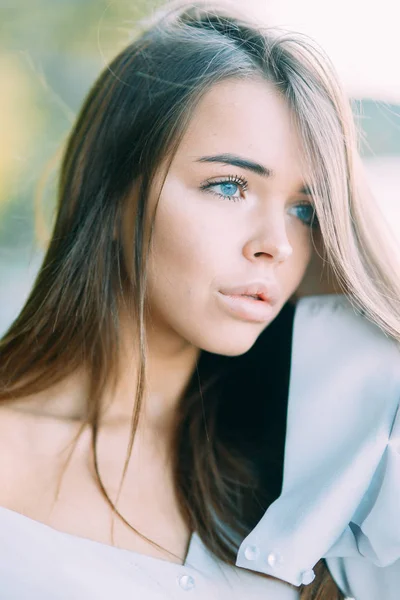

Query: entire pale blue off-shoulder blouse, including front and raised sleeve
left=0, top=295, right=400, bottom=600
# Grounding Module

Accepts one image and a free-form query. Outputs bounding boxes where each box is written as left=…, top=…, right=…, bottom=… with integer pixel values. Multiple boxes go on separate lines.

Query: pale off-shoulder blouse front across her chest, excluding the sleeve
left=0, top=508, right=299, bottom=600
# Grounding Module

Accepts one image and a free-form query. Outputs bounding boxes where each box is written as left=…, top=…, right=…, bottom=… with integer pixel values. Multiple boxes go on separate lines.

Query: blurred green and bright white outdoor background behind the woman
left=0, top=0, right=400, bottom=335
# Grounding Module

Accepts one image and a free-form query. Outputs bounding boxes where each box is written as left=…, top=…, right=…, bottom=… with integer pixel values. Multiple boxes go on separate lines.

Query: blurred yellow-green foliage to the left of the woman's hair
left=0, top=0, right=164, bottom=255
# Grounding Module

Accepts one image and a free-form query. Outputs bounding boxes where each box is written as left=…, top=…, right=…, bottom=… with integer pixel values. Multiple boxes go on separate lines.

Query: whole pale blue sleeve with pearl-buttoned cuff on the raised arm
left=236, top=295, right=400, bottom=600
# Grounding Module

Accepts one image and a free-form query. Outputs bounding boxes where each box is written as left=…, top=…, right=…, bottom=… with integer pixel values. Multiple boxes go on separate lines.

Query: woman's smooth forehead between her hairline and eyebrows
left=171, top=79, right=308, bottom=189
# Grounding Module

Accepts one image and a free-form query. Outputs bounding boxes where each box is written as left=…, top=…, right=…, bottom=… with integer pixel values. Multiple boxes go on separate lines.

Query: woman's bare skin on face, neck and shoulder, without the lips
left=0, top=80, right=340, bottom=562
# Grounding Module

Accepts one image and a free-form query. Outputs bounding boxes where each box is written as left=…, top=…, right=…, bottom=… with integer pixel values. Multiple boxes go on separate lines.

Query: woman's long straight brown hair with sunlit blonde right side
left=0, top=3, right=400, bottom=600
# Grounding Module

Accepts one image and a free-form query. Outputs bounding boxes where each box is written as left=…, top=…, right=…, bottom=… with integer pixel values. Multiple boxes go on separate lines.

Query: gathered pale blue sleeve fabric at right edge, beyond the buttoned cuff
left=325, top=396, right=400, bottom=600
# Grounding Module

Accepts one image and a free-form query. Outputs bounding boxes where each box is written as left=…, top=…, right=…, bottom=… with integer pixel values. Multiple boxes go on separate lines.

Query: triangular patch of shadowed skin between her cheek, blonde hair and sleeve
left=292, top=231, right=344, bottom=301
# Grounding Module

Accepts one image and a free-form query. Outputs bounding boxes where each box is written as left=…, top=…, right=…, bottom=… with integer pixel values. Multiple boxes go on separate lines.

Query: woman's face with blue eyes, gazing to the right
left=136, top=80, right=313, bottom=356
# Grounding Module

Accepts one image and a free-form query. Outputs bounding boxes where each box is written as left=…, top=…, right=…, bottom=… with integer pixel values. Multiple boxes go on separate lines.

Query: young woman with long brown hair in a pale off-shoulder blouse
left=0, top=5, right=400, bottom=600
